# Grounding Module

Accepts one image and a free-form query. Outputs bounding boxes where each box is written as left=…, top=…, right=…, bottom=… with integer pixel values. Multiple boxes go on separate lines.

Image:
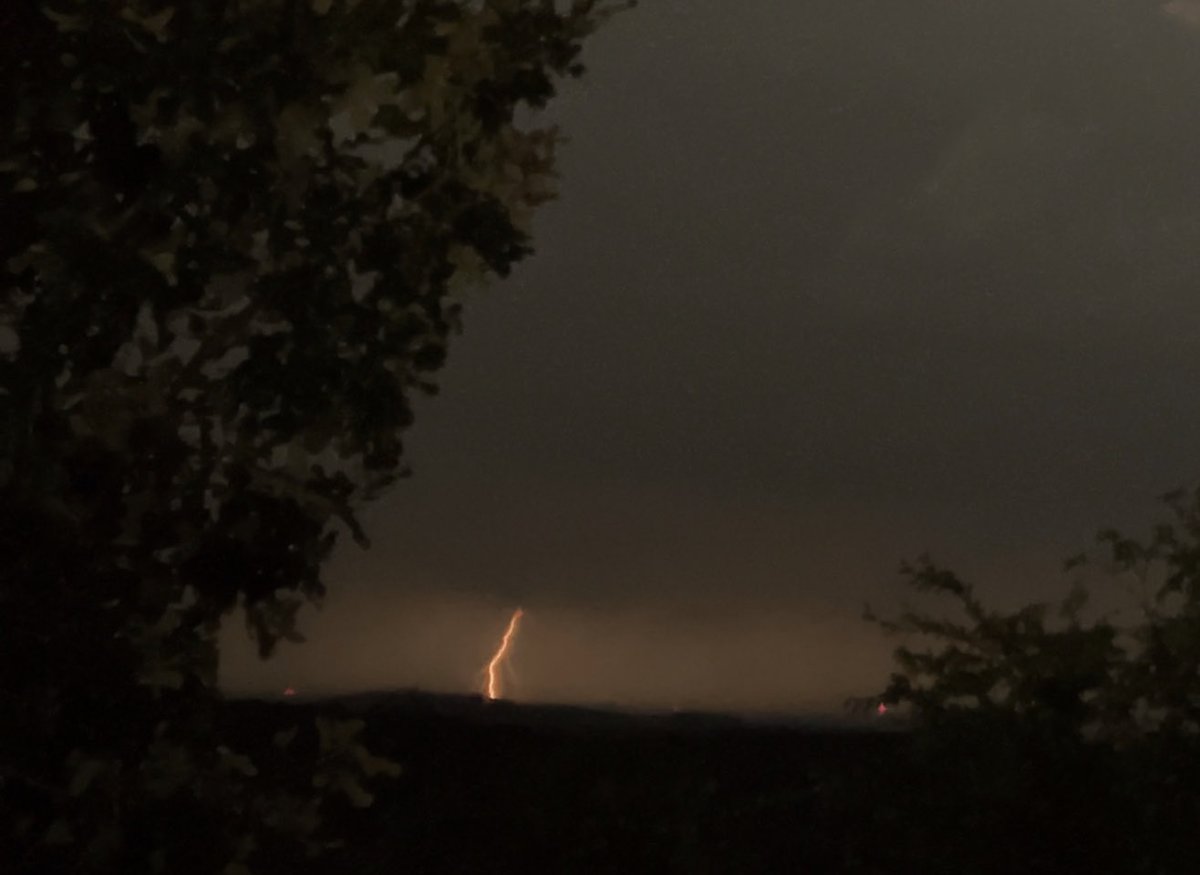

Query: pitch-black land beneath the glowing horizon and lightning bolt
left=226, top=694, right=1200, bottom=875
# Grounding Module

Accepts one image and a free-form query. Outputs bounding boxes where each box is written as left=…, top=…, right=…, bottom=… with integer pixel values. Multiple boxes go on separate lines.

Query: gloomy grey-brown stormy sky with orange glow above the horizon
left=223, top=0, right=1200, bottom=711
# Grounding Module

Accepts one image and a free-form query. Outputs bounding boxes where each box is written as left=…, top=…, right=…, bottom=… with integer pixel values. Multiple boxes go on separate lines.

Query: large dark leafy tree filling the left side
left=0, top=0, right=633, bottom=871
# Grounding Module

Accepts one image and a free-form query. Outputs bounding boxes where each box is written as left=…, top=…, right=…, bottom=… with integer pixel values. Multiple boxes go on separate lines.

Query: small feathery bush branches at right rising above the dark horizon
left=876, top=489, right=1200, bottom=744
